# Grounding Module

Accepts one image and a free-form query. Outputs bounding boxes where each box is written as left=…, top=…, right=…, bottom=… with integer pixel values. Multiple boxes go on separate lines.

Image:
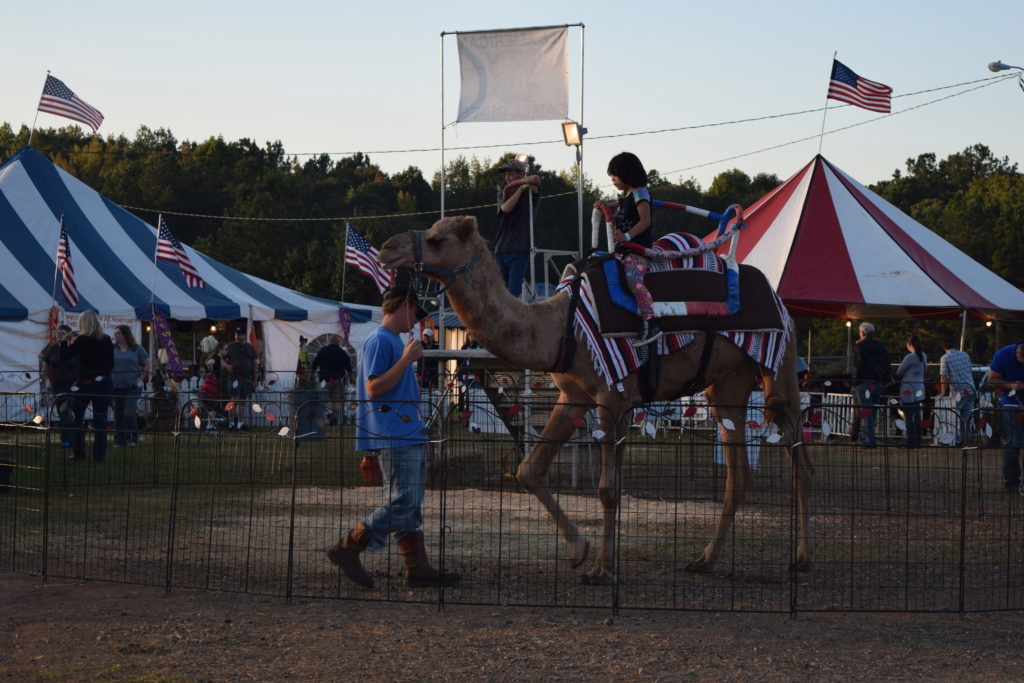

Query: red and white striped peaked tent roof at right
left=709, top=155, right=1024, bottom=319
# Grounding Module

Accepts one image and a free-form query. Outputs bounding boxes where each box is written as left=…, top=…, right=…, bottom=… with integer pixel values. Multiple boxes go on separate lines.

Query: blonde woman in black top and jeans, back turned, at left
left=60, top=310, right=114, bottom=463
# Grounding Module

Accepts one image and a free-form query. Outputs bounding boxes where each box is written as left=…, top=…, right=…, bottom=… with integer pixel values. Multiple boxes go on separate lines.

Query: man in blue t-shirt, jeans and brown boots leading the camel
left=327, top=287, right=462, bottom=588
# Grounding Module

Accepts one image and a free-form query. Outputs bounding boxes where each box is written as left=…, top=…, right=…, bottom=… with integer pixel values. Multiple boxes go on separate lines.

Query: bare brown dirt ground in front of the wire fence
left=0, top=572, right=1024, bottom=681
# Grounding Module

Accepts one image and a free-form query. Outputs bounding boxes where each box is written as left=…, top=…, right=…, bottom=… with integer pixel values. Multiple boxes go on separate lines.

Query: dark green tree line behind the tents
left=0, top=123, right=1024, bottom=360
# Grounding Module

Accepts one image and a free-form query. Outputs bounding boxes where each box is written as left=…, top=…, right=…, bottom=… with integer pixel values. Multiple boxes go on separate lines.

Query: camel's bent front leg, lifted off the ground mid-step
left=516, top=402, right=590, bottom=568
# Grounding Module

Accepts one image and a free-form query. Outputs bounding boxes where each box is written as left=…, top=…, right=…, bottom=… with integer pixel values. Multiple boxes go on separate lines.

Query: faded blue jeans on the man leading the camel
left=362, top=443, right=427, bottom=550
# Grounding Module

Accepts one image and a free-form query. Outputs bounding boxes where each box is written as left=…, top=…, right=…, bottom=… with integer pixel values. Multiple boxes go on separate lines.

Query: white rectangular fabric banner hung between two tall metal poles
left=457, top=27, right=569, bottom=122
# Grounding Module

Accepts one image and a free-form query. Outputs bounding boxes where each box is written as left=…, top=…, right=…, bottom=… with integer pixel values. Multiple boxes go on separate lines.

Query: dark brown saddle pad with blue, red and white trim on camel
left=584, top=236, right=784, bottom=337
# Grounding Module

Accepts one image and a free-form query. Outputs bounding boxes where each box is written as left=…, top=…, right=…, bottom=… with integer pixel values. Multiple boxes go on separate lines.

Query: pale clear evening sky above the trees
left=0, top=0, right=1024, bottom=201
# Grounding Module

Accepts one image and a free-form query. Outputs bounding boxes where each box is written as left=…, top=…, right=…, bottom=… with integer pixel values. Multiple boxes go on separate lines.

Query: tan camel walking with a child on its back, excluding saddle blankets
left=378, top=216, right=813, bottom=585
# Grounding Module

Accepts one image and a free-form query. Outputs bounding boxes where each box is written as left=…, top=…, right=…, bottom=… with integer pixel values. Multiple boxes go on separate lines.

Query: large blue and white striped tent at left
left=0, top=146, right=370, bottom=371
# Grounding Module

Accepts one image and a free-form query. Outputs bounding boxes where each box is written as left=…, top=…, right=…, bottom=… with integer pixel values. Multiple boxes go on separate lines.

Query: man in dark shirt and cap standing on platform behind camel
left=495, top=159, right=541, bottom=298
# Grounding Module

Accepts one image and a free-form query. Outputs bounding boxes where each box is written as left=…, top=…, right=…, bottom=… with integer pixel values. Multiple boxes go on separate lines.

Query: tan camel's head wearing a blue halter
left=377, top=216, right=485, bottom=280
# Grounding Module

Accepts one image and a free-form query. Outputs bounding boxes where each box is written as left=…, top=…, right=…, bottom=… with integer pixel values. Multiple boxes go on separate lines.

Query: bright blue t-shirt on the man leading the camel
left=355, top=327, right=427, bottom=451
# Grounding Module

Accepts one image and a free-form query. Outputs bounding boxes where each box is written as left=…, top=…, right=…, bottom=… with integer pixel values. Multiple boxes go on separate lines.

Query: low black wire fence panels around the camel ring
left=0, top=387, right=1024, bottom=613
